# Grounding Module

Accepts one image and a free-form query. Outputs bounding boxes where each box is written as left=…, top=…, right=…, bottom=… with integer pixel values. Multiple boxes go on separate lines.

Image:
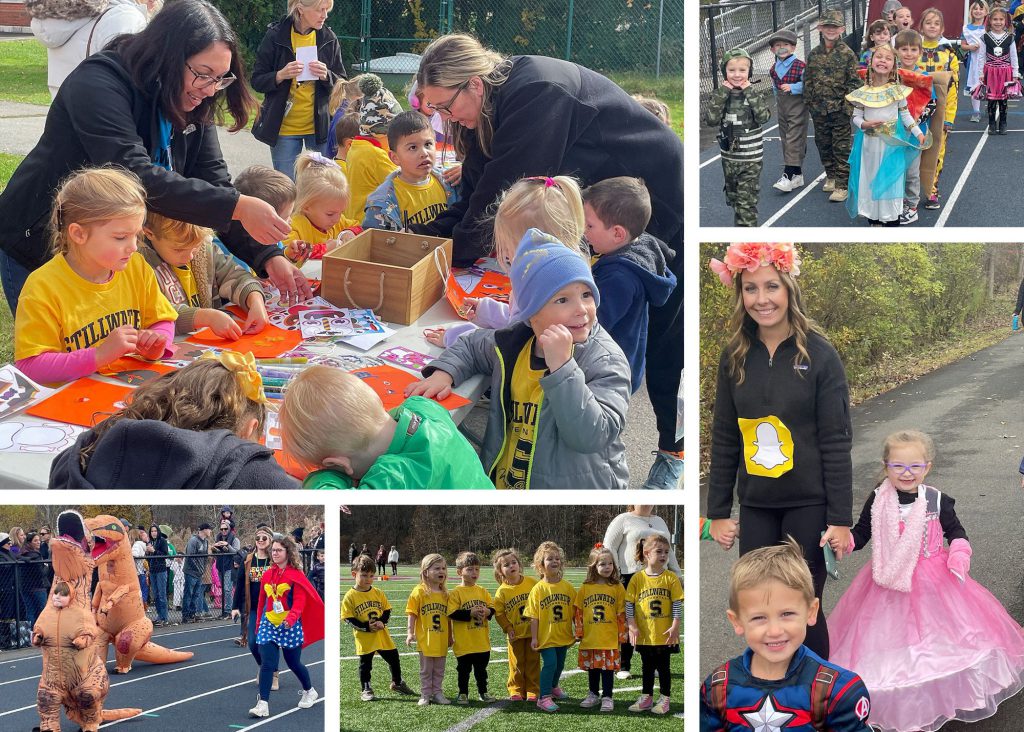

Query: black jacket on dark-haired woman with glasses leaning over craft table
left=0, top=51, right=281, bottom=271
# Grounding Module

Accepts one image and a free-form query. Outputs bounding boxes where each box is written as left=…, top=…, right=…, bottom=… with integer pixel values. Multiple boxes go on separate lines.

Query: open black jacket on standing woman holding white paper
left=249, top=16, right=347, bottom=145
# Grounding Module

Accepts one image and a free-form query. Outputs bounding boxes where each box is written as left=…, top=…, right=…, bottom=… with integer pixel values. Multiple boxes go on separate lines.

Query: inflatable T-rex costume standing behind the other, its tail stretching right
left=85, top=516, right=193, bottom=674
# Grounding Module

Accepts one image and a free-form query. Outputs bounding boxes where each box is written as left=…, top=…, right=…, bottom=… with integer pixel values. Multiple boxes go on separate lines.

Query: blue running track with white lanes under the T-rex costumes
left=0, top=622, right=323, bottom=732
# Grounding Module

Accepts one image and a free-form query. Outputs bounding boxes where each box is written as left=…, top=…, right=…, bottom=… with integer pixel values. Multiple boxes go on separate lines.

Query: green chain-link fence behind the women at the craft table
left=214, top=0, right=683, bottom=77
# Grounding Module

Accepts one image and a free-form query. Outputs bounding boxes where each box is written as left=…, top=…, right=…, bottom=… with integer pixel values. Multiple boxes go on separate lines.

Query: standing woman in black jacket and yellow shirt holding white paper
left=252, top=0, right=345, bottom=179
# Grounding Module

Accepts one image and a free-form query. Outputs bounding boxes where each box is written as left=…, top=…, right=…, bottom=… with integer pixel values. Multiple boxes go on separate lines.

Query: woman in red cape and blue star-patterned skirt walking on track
left=249, top=535, right=324, bottom=717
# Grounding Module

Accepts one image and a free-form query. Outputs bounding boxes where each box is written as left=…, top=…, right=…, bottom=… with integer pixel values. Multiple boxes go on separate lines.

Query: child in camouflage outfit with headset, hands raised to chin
left=703, top=48, right=771, bottom=226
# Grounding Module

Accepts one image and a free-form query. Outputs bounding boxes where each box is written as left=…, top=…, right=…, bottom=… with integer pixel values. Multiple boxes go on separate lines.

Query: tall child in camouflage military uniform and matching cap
left=804, top=10, right=861, bottom=202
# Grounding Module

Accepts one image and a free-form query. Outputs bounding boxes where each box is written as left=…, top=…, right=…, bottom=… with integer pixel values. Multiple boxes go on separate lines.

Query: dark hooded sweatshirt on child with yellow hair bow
left=50, top=420, right=299, bottom=489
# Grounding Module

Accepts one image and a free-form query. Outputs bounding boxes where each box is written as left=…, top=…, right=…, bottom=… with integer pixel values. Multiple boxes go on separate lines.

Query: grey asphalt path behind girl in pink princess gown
left=700, top=336, right=1024, bottom=732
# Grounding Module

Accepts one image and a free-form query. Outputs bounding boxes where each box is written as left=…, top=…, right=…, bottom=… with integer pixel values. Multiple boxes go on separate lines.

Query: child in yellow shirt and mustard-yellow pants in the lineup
left=492, top=549, right=541, bottom=701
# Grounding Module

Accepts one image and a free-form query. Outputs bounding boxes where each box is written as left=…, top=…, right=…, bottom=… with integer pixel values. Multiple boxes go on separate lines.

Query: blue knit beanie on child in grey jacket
left=510, top=228, right=601, bottom=320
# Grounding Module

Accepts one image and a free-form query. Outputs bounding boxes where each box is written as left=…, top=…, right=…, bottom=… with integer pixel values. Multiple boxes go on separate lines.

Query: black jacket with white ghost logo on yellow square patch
left=708, top=318, right=853, bottom=528
